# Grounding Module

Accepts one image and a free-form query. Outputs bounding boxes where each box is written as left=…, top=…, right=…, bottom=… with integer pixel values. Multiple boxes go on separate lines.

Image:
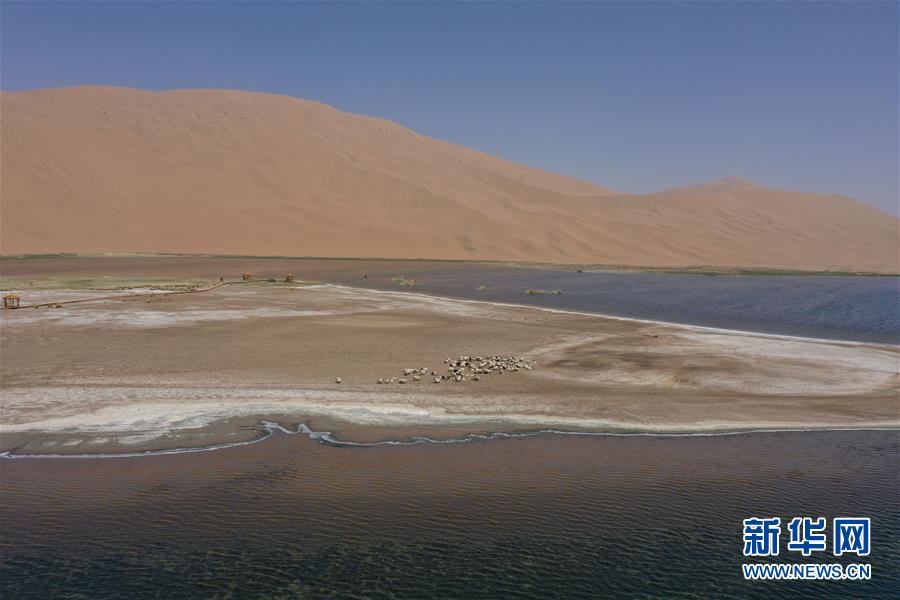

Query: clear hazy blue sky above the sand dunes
left=0, top=2, right=900, bottom=213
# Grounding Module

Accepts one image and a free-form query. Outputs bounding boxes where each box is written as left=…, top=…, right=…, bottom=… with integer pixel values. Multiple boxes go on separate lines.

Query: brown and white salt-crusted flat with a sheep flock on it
left=0, top=285, right=900, bottom=453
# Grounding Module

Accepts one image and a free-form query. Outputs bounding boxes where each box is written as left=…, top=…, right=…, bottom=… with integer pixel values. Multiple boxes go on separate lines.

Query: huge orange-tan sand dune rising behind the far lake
left=0, top=87, right=900, bottom=272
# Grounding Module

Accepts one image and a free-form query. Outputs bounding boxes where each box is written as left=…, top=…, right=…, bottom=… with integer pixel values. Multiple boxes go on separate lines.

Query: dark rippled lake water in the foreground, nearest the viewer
left=0, top=432, right=900, bottom=599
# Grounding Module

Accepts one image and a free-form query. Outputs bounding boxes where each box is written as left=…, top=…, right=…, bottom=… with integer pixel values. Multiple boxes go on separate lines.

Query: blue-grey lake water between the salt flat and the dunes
left=322, top=264, right=900, bottom=344
